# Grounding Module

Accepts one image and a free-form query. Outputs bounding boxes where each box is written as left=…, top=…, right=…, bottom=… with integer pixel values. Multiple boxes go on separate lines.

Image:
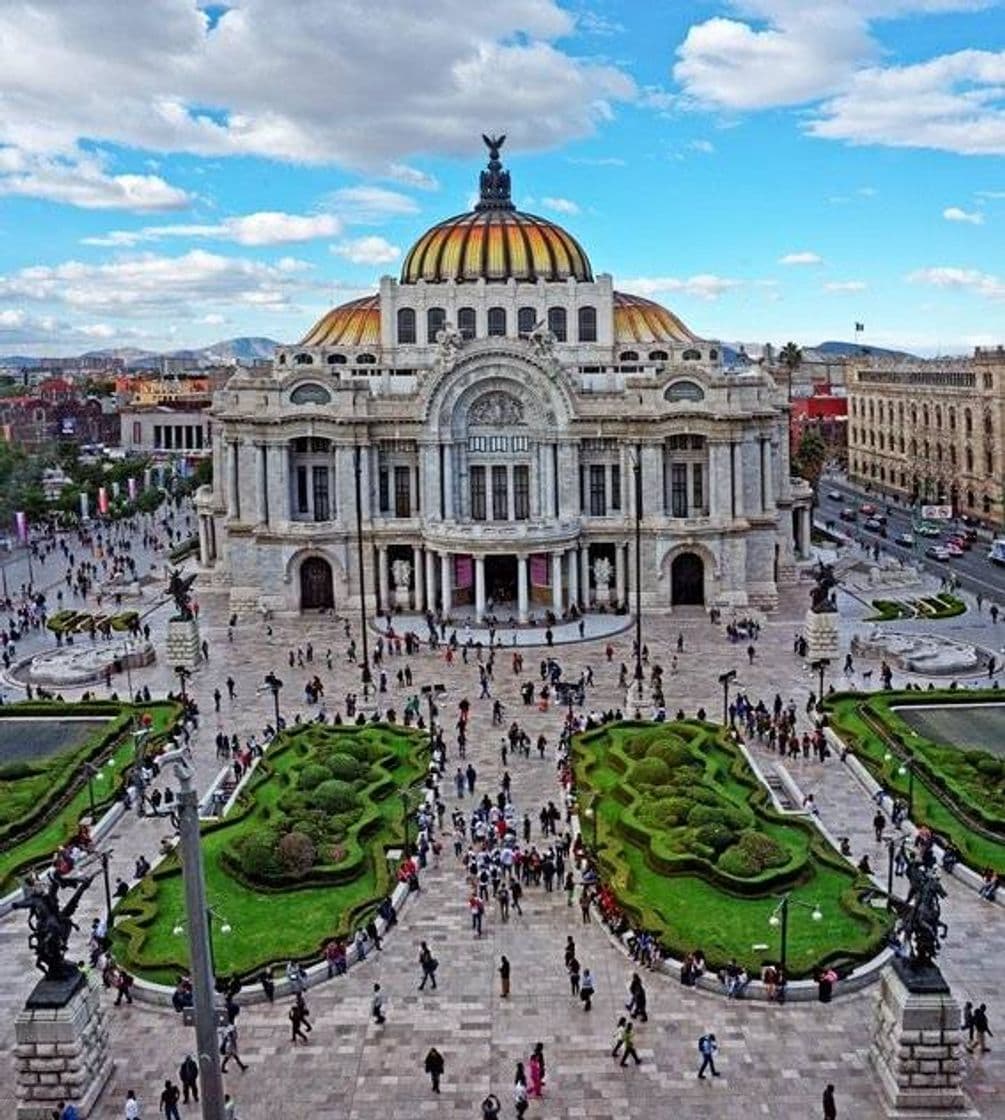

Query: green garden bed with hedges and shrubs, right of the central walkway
left=574, top=722, right=887, bottom=977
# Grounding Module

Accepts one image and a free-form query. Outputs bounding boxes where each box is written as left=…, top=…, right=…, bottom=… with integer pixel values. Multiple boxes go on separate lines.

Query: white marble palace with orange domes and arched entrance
left=196, top=140, right=809, bottom=622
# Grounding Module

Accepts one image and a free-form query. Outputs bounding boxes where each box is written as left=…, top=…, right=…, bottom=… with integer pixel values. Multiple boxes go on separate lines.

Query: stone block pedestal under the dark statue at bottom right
left=869, top=960, right=978, bottom=1120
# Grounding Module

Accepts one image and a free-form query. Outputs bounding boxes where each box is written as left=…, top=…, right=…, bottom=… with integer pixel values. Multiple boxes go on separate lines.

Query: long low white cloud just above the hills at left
left=0, top=250, right=308, bottom=319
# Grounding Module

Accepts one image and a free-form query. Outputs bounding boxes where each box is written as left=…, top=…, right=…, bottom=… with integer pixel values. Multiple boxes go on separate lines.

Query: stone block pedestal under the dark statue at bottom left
left=15, top=973, right=113, bottom=1120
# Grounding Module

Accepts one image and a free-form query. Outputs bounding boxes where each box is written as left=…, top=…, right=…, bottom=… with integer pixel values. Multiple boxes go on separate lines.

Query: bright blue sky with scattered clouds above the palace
left=0, top=0, right=1005, bottom=354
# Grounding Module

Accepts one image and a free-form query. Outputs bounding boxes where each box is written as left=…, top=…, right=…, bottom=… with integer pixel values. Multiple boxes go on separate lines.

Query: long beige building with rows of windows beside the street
left=848, top=346, right=1005, bottom=525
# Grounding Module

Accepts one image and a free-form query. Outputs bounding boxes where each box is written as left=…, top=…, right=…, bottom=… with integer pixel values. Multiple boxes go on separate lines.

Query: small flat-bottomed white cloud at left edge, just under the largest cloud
left=0, top=147, right=192, bottom=211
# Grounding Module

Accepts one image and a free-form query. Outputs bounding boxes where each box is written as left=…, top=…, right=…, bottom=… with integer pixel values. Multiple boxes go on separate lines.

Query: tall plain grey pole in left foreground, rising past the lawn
left=160, top=750, right=224, bottom=1120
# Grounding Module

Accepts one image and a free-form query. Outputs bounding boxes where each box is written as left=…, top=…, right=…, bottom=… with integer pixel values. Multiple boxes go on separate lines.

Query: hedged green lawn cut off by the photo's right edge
left=827, top=689, right=1005, bottom=870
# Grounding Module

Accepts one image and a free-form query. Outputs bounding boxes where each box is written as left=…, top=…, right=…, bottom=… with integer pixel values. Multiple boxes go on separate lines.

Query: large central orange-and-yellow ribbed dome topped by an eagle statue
left=401, top=137, right=593, bottom=283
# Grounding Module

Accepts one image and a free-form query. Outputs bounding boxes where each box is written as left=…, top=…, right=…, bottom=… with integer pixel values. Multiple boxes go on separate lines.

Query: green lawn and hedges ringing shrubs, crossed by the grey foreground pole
left=114, top=725, right=427, bottom=983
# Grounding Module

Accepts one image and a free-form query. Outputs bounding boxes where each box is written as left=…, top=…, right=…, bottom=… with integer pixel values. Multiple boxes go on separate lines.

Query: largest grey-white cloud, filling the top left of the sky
left=0, top=0, right=635, bottom=174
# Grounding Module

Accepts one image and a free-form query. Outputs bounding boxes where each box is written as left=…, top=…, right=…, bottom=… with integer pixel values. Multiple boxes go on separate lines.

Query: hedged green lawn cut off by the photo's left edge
left=0, top=701, right=179, bottom=893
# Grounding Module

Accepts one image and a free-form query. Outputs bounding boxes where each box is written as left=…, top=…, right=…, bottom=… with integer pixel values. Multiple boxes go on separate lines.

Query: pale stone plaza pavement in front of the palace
left=0, top=551, right=1005, bottom=1120
